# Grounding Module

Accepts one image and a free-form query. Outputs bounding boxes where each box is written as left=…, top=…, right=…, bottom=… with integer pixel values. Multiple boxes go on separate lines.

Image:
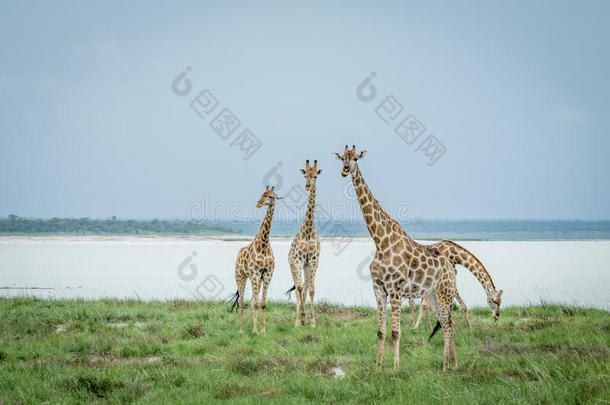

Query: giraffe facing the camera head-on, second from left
left=288, top=160, right=322, bottom=328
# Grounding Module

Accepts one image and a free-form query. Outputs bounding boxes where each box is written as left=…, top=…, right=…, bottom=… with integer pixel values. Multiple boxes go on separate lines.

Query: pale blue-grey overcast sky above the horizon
left=0, top=1, right=610, bottom=219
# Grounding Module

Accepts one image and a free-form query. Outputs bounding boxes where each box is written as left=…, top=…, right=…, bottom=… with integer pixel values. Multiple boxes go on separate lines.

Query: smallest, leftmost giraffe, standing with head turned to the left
left=231, top=186, right=282, bottom=334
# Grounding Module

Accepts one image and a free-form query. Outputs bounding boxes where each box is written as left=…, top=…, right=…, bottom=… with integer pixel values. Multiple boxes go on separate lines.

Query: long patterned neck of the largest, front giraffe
left=352, top=165, right=413, bottom=251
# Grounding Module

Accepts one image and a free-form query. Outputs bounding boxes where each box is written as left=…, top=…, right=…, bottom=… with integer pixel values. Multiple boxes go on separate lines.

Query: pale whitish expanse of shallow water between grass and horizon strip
left=0, top=237, right=610, bottom=310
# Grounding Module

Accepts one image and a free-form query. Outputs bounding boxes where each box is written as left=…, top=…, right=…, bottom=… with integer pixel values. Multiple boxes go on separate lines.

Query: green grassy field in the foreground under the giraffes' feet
left=0, top=298, right=610, bottom=404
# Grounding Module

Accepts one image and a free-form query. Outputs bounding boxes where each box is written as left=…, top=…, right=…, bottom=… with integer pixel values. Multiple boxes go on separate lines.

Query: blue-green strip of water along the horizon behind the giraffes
left=217, top=219, right=610, bottom=240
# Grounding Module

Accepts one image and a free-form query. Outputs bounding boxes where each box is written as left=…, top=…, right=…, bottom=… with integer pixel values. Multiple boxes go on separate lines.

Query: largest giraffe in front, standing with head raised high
left=334, top=145, right=499, bottom=371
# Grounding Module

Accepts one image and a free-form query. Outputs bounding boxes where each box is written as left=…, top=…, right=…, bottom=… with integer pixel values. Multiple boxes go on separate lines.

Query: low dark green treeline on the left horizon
left=0, top=215, right=235, bottom=235
